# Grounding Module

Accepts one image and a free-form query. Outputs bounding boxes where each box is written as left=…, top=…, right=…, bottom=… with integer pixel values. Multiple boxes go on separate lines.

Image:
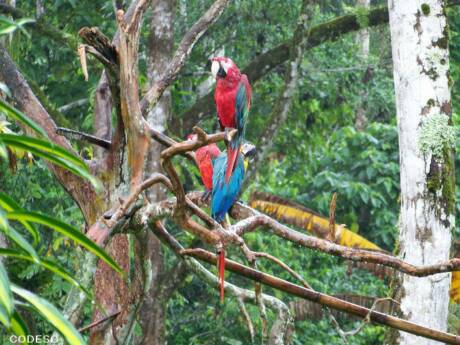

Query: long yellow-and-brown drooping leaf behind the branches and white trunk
left=249, top=193, right=460, bottom=303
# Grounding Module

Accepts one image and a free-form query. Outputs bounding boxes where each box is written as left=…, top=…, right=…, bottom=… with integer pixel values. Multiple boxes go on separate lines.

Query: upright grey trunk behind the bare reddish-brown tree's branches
left=135, top=0, right=175, bottom=345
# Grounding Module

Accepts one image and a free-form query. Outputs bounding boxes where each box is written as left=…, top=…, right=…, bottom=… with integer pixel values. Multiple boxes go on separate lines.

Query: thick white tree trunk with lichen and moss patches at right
left=388, top=0, right=455, bottom=345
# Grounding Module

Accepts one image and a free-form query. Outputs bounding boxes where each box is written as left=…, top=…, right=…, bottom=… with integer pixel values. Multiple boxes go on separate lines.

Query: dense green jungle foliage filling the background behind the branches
left=0, top=0, right=460, bottom=345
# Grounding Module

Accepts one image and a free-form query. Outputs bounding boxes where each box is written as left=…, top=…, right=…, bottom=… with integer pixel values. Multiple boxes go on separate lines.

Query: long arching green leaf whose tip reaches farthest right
left=6, top=212, right=124, bottom=274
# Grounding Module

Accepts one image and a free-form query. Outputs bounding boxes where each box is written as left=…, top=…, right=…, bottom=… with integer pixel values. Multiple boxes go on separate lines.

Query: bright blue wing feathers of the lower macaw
left=211, top=153, right=244, bottom=222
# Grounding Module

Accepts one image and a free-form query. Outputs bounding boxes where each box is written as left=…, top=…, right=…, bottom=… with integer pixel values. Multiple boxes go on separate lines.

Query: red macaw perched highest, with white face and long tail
left=211, top=56, right=252, bottom=183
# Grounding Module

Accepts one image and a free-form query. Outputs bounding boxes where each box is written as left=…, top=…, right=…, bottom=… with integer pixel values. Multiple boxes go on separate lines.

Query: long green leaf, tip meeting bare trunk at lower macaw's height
left=0, top=134, right=100, bottom=189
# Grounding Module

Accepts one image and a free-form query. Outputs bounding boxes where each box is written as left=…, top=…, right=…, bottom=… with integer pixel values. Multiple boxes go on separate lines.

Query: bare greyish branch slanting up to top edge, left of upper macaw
left=141, top=0, right=230, bottom=114
